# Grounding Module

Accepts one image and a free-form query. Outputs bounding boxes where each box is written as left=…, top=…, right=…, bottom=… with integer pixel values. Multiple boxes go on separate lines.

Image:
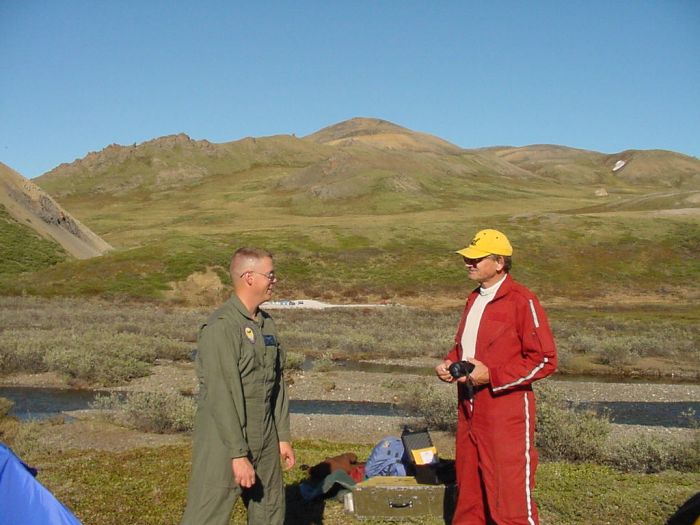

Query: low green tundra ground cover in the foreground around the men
left=10, top=441, right=700, bottom=525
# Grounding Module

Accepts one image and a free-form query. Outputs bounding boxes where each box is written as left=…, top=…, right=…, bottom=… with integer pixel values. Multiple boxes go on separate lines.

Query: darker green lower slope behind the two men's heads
left=0, top=205, right=700, bottom=299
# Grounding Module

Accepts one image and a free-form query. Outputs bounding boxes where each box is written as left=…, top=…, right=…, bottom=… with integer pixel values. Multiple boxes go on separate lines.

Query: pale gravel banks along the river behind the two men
left=0, top=360, right=700, bottom=456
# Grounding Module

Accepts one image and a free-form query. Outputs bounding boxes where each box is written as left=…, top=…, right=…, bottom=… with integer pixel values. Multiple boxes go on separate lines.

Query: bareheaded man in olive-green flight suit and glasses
left=181, top=248, right=295, bottom=525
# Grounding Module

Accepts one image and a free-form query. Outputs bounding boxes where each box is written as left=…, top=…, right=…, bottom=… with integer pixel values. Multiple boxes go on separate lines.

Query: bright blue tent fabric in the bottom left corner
left=0, top=443, right=80, bottom=525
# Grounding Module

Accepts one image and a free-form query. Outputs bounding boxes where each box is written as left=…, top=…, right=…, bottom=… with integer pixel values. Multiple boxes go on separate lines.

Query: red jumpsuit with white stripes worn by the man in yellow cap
left=446, top=275, right=557, bottom=525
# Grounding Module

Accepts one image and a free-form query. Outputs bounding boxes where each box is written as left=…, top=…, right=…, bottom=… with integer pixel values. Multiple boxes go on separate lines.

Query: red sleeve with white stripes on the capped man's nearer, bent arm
left=489, top=295, right=557, bottom=393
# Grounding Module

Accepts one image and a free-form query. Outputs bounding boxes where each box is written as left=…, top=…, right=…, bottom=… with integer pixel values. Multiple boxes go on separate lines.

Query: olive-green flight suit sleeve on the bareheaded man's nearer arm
left=198, top=319, right=249, bottom=458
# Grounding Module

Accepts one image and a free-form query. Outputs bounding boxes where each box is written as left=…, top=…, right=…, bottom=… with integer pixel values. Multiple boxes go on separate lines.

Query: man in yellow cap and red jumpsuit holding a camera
left=435, top=230, right=557, bottom=525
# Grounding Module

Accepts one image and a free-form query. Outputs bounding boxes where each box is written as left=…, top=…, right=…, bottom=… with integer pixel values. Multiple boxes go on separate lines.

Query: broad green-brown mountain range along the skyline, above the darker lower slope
left=35, top=118, right=700, bottom=230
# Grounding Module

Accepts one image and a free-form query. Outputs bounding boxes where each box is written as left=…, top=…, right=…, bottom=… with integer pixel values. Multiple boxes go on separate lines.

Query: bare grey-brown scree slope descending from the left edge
left=0, top=163, right=112, bottom=259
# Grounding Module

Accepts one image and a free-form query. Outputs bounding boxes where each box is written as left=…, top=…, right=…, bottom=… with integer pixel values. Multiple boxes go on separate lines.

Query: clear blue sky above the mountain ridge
left=0, top=0, right=700, bottom=178
